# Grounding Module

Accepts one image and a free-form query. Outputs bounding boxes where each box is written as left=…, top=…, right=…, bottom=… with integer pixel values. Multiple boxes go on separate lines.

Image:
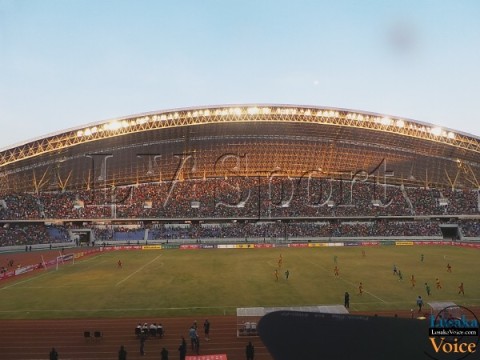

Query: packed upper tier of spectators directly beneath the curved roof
left=0, top=177, right=480, bottom=220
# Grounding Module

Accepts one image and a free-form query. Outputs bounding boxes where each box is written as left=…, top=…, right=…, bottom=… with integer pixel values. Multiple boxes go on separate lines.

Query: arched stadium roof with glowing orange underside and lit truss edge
left=0, top=104, right=480, bottom=193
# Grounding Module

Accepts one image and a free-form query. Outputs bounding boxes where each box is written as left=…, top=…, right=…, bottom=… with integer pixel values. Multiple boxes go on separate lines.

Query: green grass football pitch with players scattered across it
left=0, top=246, right=480, bottom=319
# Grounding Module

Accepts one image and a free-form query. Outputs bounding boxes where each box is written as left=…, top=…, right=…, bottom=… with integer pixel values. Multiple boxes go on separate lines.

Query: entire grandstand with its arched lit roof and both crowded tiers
left=0, top=105, right=480, bottom=246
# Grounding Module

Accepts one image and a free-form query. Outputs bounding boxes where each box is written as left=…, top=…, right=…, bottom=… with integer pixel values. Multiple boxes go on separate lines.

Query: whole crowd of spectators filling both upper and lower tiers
left=0, top=177, right=480, bottom=246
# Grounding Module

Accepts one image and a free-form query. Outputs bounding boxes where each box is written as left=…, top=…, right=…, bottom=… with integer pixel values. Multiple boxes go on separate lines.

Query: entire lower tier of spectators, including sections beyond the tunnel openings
left=0, top=218, right=480, bottom=246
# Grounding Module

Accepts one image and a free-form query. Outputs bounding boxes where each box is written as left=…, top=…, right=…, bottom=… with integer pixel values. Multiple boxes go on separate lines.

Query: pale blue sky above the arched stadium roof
left=0, top=0, right=480, bottom=149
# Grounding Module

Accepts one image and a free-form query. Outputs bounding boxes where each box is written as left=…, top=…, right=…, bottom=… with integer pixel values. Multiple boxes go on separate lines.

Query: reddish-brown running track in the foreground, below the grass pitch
left=0, top=316, right=273, bottom=360
